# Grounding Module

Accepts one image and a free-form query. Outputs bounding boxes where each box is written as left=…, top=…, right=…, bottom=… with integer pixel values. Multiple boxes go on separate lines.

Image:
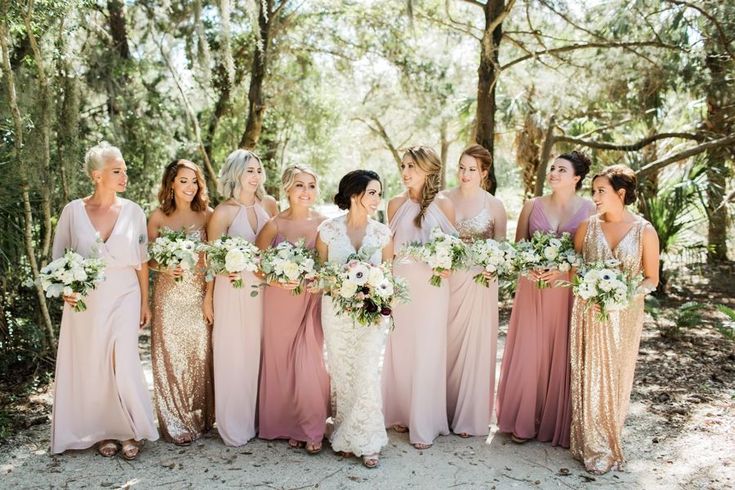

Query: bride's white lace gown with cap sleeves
left=319, top=215, right=391, bottom=456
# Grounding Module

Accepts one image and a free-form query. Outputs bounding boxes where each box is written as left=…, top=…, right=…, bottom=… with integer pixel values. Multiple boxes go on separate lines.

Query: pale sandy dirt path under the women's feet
left=0, top=326, right=735, bottom=489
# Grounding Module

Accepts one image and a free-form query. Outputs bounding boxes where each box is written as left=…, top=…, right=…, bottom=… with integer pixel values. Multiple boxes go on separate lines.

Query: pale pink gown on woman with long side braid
left=383, top=199, right=456, bottom=444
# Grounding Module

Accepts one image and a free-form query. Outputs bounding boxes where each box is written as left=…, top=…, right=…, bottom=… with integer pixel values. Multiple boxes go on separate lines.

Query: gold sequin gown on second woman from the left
left=151, top=229, right=214, bottom=442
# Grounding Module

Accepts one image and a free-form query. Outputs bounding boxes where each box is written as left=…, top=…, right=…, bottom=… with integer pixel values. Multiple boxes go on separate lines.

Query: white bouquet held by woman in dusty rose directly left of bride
left=260, top=240, right=316, bottom=295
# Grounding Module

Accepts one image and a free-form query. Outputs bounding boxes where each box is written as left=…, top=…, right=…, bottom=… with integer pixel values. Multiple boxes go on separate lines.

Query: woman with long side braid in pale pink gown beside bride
left=383, top=146, right=456, bottom=449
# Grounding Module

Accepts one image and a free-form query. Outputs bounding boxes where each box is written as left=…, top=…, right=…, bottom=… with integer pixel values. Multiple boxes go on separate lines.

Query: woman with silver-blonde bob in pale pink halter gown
left=204, top=150, right=278, bottom=446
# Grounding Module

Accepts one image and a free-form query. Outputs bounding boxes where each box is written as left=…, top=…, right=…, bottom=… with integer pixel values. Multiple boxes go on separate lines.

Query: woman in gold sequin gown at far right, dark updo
left=571, top=165, right=659, bottom=474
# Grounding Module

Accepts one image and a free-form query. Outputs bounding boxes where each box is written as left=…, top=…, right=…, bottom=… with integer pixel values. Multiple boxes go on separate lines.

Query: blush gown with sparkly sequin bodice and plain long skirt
left=447, top=207, right=498, bottom=436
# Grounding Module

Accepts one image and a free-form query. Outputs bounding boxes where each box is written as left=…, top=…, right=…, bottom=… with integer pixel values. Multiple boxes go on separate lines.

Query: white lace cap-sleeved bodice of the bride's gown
left=319, top=214, right=391, bottom=264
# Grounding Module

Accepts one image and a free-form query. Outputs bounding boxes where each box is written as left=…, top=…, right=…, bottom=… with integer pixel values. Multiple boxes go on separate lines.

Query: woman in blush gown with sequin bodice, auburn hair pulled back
left=445, top=145, right=507, bottom=437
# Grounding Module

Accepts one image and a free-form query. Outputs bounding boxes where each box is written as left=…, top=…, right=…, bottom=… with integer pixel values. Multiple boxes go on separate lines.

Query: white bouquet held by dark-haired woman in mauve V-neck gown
left=515, top=231, right=581, bottom=289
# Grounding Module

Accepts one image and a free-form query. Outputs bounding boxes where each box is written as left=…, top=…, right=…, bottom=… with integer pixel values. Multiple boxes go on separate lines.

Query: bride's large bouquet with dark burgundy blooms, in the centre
left=319, top=259, right=408, bottom=326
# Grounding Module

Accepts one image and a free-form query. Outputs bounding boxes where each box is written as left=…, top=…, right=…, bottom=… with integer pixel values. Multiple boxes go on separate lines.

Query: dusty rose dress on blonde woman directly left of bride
left=258, top=218, right=330, bottom=443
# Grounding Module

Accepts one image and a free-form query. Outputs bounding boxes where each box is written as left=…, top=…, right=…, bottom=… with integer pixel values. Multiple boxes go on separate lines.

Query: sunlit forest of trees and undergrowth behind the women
left=0, top=0, right=735, bottom=448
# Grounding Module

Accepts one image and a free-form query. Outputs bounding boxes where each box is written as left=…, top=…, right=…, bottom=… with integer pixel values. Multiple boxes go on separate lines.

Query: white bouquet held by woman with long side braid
left=403, top=228, right=467, bottom=287
